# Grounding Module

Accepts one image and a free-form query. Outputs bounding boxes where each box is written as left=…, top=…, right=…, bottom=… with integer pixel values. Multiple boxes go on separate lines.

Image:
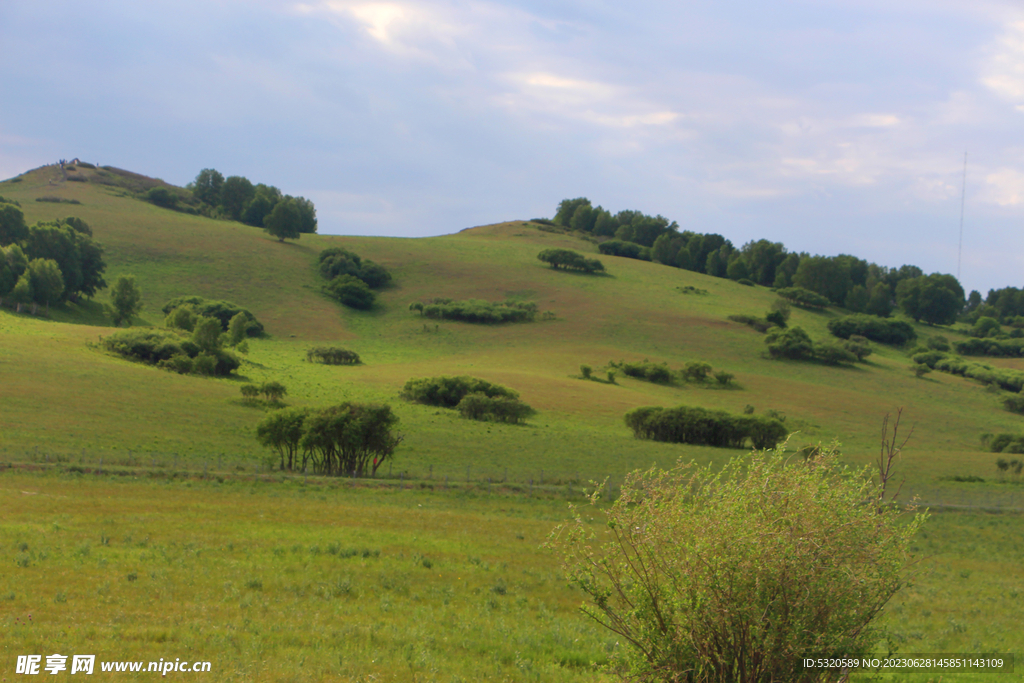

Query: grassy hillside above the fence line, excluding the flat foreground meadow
left=0, top=165, right=1020, bottom=493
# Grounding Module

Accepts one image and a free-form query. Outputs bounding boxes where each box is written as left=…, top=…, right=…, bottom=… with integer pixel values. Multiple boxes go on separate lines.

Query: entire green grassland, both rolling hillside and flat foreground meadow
left=0, top=167, right=1024, bottom=681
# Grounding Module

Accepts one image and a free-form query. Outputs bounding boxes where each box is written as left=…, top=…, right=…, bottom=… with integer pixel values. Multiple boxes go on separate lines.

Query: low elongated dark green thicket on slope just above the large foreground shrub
left=626, top=405, right=787, bottom=449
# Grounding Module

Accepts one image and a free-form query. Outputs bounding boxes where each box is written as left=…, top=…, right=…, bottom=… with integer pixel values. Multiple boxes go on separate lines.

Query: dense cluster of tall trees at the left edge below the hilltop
left=0, top=198, right=106, bottom=308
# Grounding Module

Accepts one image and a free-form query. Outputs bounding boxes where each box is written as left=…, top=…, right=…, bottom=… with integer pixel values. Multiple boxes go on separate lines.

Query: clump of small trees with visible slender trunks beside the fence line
left=256, top=401, right=402, bottom=477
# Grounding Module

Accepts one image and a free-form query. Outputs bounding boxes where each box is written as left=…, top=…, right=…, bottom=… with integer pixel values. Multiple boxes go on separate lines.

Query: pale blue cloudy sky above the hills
left=0, top=0, right=1024, bottom=294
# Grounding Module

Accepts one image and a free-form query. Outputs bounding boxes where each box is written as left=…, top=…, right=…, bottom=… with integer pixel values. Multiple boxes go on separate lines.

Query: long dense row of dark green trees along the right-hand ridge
left=553, top=197, right=970, bottom=325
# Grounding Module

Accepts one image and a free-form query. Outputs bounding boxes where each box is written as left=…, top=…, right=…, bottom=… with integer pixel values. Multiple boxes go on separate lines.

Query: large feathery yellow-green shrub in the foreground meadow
left=550, top=445, right=926, bottom=683
